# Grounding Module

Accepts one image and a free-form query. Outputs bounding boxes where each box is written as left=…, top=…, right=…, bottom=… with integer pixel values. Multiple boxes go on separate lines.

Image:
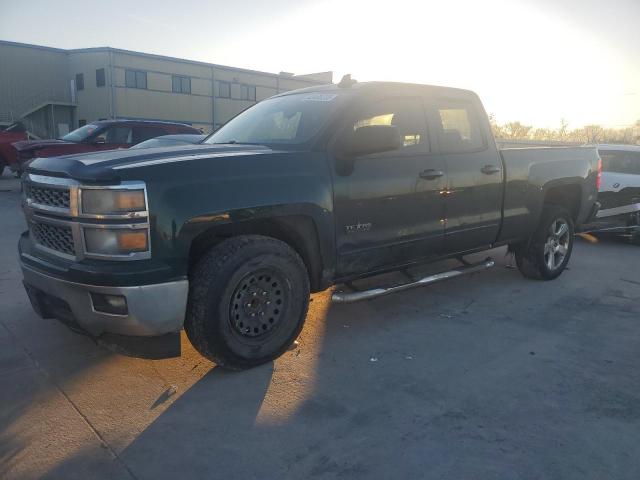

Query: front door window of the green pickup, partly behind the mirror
left=353, top=97, right=429, bottom=153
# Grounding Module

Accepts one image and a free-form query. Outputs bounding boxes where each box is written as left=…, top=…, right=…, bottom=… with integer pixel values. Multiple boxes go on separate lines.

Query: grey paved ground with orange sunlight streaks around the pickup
left=0, top=174, right=640, bottom=480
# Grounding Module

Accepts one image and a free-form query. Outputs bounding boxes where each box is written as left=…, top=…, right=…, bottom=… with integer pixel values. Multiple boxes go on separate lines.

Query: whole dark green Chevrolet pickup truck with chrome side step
left=19, top=81, right=599, bottom=368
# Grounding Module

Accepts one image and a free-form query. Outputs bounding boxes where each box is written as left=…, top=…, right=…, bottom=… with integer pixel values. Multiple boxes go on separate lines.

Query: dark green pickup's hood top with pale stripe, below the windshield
left=27, top=144, right=273, bottom=183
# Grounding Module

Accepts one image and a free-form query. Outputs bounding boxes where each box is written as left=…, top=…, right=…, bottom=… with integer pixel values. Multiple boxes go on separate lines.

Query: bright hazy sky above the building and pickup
left=0, top=0, right=640, bottom=128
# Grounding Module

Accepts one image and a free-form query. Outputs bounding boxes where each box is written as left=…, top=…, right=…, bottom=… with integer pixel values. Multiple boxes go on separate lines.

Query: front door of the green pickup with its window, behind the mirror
left=334, top=97, right=446, bottom=276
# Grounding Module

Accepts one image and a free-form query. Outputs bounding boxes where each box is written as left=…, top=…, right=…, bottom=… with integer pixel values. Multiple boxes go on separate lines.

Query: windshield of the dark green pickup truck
left=204, top=93, right=341, bottom=145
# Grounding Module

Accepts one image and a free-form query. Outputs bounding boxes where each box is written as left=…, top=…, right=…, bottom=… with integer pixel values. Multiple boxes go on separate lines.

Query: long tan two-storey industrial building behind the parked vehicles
left=0, top=41, right=333, bottom=138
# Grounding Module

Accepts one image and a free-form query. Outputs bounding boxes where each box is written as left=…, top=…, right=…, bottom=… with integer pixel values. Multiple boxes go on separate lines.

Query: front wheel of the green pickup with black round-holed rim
left=184, top=235, right=309, bottom=370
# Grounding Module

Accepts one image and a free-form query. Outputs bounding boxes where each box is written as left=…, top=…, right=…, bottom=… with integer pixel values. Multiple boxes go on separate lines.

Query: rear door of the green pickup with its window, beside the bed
left=428, top=98, right=504, bottom=254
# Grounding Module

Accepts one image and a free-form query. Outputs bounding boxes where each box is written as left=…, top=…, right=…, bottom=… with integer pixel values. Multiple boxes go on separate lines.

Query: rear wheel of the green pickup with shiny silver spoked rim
left=514, top=205, right=575, bottom=280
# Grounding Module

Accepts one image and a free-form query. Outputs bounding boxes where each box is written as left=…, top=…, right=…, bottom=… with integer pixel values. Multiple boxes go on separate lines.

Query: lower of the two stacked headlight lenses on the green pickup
left=84, top=227, right=149, bottom=255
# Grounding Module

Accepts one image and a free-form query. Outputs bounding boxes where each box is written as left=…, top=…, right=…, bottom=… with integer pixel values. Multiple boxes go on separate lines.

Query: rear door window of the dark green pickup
left=436, top=101, right=485, bottom=153
